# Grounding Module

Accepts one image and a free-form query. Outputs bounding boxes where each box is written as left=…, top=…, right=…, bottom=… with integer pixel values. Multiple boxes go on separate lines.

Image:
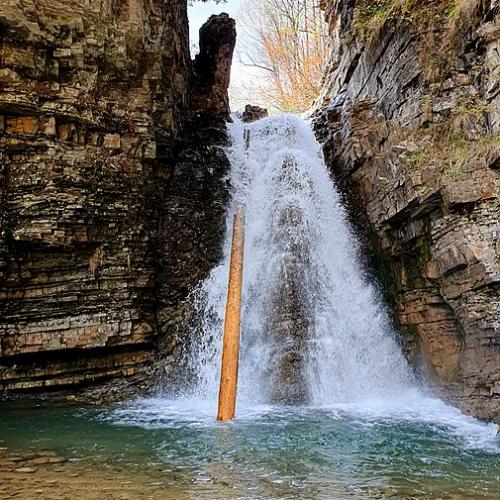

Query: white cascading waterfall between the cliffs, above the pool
left=189, top=115, right=414, bottom=404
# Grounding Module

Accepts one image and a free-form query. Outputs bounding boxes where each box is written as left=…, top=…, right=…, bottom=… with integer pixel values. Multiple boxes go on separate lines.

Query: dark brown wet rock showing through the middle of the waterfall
left=263, top=160, right=317, bottom=405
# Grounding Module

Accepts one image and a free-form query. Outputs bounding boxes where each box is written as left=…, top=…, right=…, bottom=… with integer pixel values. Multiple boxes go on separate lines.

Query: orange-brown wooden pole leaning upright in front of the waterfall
left=217, top=207, right=245, bottom=421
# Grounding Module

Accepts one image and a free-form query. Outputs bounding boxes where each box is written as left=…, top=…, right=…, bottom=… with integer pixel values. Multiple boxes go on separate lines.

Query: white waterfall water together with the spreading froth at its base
left=110, top=115, right=498, bottom=453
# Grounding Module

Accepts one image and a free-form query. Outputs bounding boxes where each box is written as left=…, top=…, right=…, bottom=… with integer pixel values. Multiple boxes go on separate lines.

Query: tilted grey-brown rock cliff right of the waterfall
left=315, top=0, right=500, bottom=418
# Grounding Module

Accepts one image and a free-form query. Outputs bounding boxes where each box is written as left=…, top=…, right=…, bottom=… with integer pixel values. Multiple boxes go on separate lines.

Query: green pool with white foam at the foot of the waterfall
left=0, top=394, right=500, bottom=499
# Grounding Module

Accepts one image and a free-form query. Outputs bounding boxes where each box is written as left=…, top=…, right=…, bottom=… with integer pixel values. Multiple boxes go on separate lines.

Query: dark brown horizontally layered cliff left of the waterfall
left=0, top=0, right=235, bottom=390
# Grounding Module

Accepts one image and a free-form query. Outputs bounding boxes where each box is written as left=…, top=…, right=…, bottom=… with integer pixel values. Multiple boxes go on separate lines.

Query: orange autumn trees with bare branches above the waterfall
left=243, top=0, right=328, bottom=112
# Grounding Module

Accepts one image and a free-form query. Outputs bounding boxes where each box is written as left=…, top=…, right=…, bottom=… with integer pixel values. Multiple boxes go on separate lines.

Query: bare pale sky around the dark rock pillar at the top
left=188, top=0, right=264, bottom=111
